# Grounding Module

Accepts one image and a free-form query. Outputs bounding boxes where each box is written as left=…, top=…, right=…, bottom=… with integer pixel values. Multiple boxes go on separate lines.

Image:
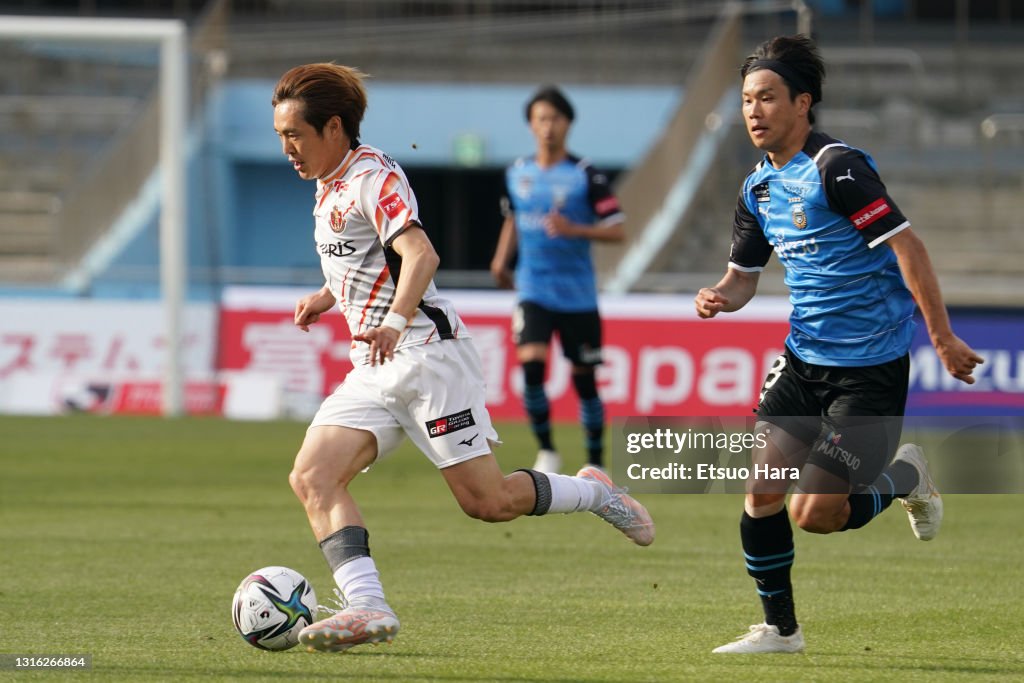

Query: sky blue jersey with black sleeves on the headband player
left=729, top=132, right=914, bottom=367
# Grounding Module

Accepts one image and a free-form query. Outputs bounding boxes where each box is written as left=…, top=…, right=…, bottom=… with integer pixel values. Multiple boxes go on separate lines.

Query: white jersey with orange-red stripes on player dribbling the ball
left=313, top=144, right=469, bottom=366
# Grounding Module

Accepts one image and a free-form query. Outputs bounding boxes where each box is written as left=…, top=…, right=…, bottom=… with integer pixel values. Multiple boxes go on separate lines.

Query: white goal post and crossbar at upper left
left=0, top=15, right=188, bottom=416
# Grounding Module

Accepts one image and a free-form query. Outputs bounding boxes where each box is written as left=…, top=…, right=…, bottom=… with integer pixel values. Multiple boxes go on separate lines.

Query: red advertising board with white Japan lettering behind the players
left=218, top=288, right=788, bottom=420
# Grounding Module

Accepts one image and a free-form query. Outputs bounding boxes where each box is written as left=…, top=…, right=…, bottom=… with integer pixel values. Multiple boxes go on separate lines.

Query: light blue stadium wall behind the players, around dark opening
left=88, top=80, right=681, bottom=300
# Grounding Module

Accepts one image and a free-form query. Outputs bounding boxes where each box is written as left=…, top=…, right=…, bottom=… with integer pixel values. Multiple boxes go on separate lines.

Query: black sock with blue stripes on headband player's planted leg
left=739, top=507, right=797, bottom=636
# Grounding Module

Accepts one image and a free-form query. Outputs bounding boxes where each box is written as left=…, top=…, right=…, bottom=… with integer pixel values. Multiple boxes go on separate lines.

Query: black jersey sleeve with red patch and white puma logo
left=817, top=146, right=907, bottom=244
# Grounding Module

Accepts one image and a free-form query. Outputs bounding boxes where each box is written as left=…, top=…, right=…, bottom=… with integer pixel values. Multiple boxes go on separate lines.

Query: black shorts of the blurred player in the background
left=512, top=301, right=601, bottom=366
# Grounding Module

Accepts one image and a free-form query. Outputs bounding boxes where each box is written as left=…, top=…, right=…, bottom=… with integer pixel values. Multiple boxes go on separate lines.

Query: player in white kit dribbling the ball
left=272, top=63, right=654, bottom=651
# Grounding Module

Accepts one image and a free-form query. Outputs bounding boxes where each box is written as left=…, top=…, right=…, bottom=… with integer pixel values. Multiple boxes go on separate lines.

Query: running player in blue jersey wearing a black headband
left=694, top=36, right=983, bottom=653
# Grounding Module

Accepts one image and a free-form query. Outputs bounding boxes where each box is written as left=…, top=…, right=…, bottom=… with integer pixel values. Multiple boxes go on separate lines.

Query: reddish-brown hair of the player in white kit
left=270, top=62, right=367, bottom=144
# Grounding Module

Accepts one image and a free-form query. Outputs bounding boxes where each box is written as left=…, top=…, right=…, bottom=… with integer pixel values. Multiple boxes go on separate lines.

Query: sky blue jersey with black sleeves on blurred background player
left=502, top=156, right=623, bottom=312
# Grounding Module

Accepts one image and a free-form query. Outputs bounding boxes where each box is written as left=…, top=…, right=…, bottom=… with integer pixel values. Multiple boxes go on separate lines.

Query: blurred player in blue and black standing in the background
left=490, top=86, right=625, bottom=472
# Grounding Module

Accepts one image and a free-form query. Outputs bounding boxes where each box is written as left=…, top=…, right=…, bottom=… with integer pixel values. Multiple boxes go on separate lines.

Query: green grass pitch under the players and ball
left=0, top=417, right=1024, bottom=683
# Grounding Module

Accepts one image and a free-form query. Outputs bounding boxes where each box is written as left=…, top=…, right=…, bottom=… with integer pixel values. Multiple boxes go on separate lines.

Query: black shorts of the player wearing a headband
left=758, top=348, right=910, bottom=493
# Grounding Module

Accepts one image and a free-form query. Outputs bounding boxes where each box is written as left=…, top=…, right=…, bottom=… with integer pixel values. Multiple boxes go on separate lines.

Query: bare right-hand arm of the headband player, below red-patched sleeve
left=886, top=227, right=985, bottom=384
